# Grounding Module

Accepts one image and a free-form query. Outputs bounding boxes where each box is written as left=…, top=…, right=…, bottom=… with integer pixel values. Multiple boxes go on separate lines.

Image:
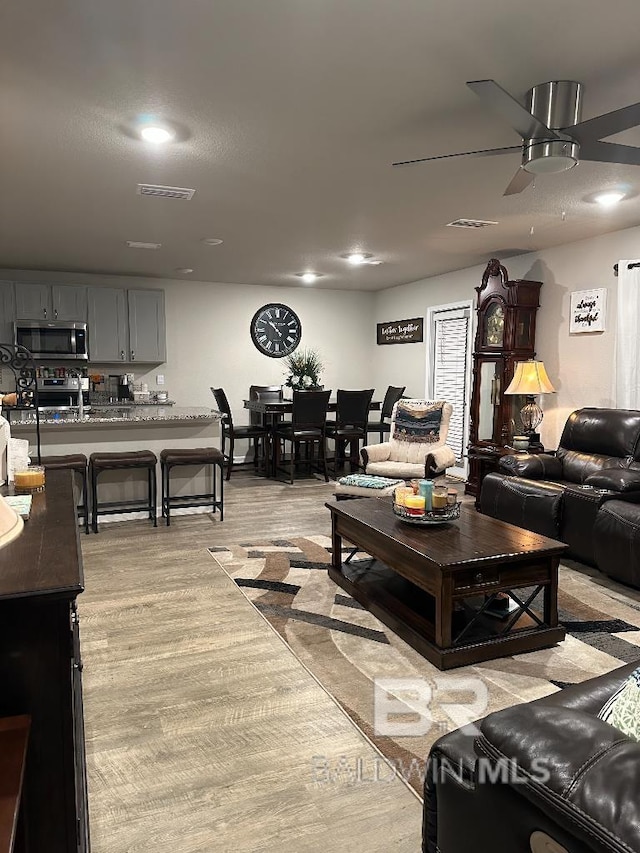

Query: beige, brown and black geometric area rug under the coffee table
left=209, top=536, right=640, bottom=793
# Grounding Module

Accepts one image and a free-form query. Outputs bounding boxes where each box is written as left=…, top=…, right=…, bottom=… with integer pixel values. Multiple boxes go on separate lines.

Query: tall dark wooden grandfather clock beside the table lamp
left=465, top=258, right=542, bottom=505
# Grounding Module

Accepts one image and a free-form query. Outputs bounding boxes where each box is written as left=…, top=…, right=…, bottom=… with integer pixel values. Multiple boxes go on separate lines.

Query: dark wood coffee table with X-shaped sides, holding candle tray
left=326, top=498, right=567, bottom=669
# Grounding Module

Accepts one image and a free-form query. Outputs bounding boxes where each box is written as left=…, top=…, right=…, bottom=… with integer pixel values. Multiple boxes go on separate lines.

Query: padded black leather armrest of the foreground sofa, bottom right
left=476, top=705, right=640, bottom=850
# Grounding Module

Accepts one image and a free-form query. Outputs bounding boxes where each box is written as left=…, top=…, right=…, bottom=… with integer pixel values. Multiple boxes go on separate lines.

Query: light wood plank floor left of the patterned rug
left=79, top=473, right=422, bottom=853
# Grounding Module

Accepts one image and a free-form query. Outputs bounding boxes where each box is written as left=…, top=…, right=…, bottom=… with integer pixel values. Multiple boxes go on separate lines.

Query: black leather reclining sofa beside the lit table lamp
left=480, top=408, right=640, bottom=586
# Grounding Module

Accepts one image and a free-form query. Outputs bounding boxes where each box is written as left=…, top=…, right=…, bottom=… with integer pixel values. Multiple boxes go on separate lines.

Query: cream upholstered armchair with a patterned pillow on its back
left=360, top=399, right=456, bottom=480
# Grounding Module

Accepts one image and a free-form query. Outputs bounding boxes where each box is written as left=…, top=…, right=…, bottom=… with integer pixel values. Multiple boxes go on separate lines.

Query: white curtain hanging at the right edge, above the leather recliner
left=615, top=260, right=640, bottom=409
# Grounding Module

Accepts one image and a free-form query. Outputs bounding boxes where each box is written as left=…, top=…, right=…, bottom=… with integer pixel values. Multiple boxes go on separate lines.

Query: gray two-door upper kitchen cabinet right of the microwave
left=88, top=287, right=166, bottom=364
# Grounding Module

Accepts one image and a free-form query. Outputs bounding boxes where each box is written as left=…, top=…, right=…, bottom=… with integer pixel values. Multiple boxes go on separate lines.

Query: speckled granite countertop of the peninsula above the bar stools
left=11, top=404, right=220, bottom=430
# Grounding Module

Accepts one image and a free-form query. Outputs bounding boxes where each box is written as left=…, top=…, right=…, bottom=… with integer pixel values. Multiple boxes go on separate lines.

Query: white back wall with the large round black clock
left=0, top=270, right=376, bottom=423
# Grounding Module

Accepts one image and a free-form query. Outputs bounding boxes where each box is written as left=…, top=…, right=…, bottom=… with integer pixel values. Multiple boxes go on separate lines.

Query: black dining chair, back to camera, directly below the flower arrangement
left=273, top=391, right=331, bottom=484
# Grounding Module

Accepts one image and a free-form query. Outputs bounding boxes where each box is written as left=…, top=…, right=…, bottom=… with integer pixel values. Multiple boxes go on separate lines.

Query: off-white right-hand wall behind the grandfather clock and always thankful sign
left=374, top=226, right=640, bottom=447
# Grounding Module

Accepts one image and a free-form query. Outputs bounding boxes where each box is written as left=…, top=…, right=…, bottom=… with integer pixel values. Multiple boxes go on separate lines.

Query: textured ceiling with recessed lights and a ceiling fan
left=0, top=0, right=640, bottom=290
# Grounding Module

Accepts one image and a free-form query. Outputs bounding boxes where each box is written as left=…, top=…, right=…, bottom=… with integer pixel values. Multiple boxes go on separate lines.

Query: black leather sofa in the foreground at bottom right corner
left=423, top=662, right=640, bottom=853
